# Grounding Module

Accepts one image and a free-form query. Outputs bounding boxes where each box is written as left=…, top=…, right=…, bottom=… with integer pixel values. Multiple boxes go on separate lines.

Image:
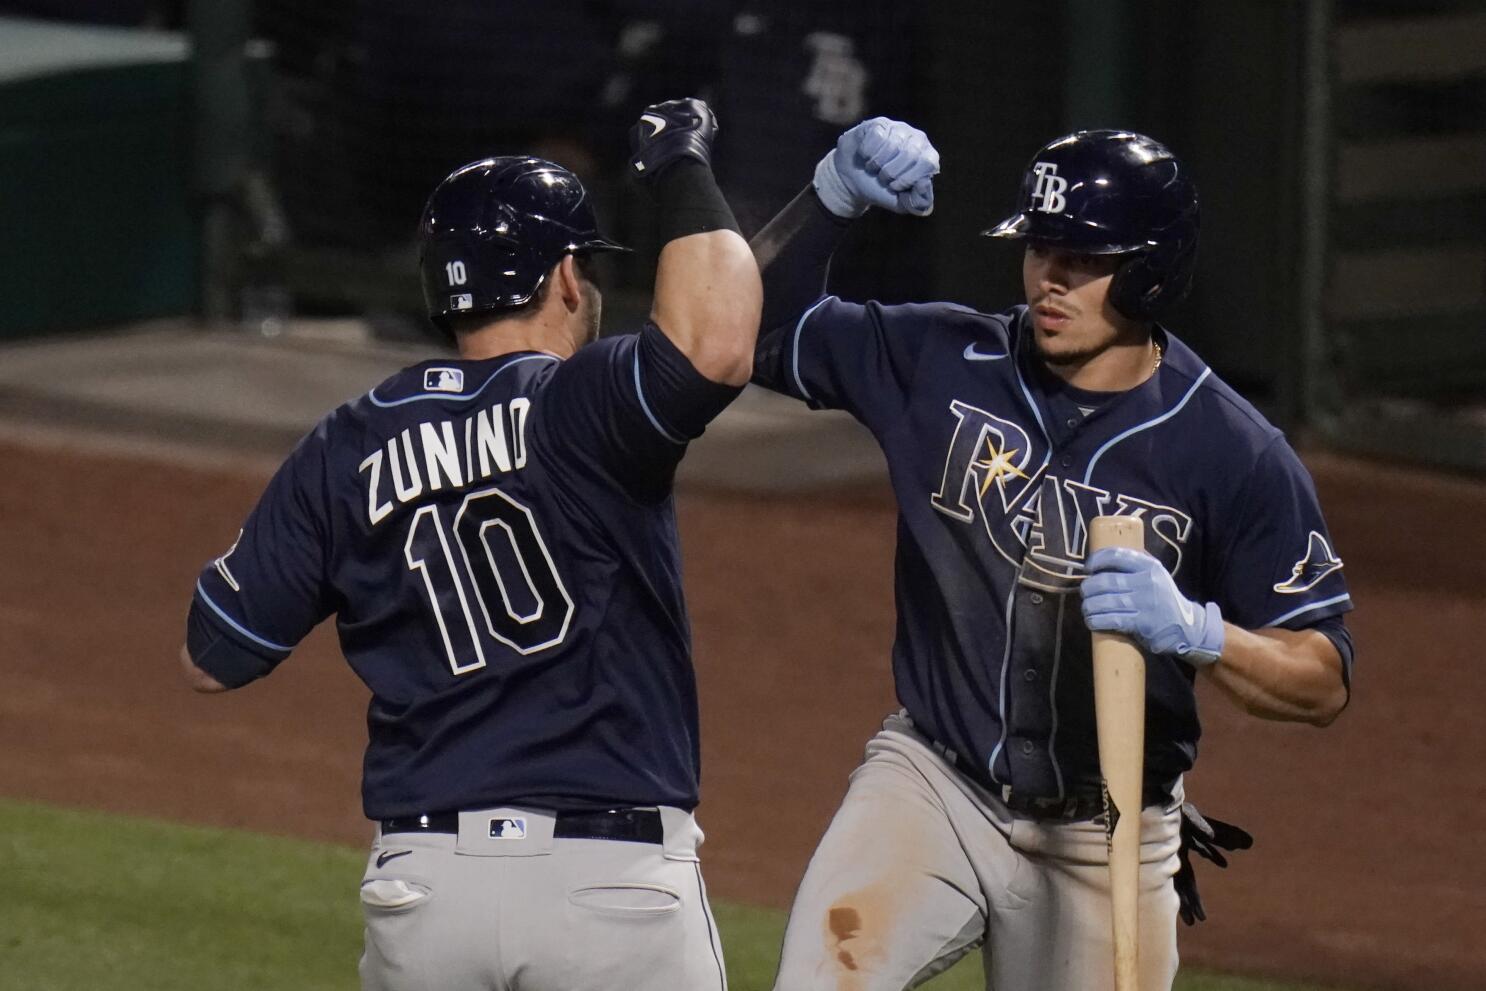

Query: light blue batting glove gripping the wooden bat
left=1082, top=547, right=1223, bottom=667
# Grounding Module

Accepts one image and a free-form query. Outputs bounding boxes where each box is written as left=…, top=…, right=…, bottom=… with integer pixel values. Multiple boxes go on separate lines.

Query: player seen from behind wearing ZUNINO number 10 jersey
left=183, top=100, right=761, bottom=991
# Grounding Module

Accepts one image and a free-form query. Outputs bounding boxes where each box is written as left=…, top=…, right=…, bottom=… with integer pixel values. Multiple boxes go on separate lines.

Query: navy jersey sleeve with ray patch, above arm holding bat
left=1216, top=437, right=1352, bottom=630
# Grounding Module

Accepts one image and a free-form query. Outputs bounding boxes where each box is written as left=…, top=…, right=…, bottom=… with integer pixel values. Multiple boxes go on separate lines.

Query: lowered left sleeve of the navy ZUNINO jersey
left=187, top=423, right=331, bottom=688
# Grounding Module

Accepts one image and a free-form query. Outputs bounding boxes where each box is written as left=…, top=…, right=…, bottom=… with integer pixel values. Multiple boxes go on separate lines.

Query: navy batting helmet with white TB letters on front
left=984, top=131, right=1198, bottom=319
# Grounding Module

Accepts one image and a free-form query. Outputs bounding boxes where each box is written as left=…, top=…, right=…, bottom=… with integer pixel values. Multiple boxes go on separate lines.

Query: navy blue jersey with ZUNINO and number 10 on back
left=193, top=325, right=737, bottom=819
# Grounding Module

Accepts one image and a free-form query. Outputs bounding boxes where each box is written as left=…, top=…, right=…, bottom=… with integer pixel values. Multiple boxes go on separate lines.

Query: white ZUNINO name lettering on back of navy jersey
left=357, top=397, right=532, bottom=526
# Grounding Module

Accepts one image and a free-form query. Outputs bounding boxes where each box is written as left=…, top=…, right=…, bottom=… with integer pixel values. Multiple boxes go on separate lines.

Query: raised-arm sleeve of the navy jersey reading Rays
left=753, top=296, right=924, bottom=429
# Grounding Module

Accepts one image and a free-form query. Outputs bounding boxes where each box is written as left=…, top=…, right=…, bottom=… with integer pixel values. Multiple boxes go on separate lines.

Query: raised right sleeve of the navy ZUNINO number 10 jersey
left=538, top=322, right=742, bottom=501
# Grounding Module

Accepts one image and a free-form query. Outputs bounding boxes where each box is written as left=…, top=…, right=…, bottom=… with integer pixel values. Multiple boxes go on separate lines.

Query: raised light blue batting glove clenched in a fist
left=814, top=117, right=939, bottom=218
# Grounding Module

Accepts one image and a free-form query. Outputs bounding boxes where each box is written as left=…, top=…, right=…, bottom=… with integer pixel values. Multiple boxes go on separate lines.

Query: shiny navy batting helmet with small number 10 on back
left=418, top=156, right=629, bottom=328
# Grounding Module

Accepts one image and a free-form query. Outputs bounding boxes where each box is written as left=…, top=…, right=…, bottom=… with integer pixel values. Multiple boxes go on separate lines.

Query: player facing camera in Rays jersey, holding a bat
left=753, top=119, right=1352, bottom=991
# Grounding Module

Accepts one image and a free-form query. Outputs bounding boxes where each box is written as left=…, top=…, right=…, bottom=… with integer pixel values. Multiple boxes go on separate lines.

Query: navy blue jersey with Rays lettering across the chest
left=755, top=297, right=1351, bottom=796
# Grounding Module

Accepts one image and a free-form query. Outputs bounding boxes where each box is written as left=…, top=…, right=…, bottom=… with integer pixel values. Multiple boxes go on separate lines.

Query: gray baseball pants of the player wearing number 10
left=361, top=808, right=727, bottom=991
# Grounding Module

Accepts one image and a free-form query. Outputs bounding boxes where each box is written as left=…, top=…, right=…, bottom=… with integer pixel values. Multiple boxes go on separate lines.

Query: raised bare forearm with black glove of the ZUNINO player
left=630, top=100, right=762, bottom=385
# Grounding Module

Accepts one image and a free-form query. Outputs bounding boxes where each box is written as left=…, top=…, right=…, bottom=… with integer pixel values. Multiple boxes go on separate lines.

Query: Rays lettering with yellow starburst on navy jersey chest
left=930, top=400, right=1192, bottom=590
